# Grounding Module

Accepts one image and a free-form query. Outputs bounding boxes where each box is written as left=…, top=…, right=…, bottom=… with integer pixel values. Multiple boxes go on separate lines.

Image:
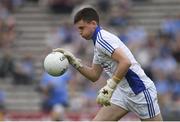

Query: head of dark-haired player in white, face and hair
left=74, top=7, right=99, bottom=40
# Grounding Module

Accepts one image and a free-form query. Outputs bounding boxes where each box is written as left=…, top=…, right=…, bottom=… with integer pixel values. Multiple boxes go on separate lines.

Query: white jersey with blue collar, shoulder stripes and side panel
left=92, top=26, right=154, bottom=94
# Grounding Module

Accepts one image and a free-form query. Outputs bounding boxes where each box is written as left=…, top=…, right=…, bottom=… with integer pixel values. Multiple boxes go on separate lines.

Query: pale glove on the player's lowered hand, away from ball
left=96, top=79, right=117, bottom=106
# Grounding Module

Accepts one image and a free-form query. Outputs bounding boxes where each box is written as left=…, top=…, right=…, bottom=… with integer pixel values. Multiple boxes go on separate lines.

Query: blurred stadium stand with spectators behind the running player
left=0, top=0, right=180, bottom=121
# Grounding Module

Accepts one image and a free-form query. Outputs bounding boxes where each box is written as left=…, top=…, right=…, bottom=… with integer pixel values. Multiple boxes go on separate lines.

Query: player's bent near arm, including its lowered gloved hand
left=96, top=48, right=131, bottom=106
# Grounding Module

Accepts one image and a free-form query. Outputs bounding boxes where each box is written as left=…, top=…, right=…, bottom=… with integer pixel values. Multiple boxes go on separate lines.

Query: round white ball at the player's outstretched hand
left=44, top=52, right=69, bottom=76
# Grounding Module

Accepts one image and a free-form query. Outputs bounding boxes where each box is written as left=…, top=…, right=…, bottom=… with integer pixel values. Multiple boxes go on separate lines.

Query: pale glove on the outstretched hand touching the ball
left=53, top=48, right=83, bottom=69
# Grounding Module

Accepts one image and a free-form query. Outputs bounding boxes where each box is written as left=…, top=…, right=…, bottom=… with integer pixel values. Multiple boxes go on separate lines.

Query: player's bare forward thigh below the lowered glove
left=93, top=103, right=128, bottom=121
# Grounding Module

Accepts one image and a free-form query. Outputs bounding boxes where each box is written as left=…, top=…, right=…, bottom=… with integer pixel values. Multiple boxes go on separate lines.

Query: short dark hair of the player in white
left=74, top=7, right=99, bottom=24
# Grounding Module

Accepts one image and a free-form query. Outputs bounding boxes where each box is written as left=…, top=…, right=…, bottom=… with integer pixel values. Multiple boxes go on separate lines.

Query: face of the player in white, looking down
left=75, top=20, right=97, bottom=40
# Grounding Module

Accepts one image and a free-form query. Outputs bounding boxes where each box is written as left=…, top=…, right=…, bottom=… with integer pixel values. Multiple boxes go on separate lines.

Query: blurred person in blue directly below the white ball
left=40, top=72, right=71, bottom=121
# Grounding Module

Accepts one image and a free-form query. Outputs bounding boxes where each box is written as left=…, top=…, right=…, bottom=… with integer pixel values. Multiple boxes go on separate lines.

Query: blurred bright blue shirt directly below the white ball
left=40, top=72, right=71, bottom=105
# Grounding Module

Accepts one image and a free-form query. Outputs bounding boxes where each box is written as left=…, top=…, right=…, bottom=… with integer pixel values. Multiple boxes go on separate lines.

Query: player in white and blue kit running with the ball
left=53, top=7, right=162, bottom=121
